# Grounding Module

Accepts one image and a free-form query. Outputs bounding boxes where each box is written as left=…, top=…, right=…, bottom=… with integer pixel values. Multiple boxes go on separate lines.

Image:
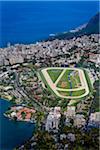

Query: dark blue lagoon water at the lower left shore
left=0, top=99, right=35, bottom=150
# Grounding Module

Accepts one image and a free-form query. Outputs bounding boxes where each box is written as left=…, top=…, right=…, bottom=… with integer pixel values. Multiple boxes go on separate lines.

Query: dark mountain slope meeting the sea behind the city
left=48, top=12, right=100, bottom=40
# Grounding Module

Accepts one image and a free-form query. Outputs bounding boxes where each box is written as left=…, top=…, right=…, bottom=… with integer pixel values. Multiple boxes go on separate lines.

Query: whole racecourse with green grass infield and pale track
left=40, top=67, right=89, bottom=99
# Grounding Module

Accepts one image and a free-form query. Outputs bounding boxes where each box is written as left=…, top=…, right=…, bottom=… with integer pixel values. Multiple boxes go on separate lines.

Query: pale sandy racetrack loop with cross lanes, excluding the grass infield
left=41, top=67, right=89, bottom=99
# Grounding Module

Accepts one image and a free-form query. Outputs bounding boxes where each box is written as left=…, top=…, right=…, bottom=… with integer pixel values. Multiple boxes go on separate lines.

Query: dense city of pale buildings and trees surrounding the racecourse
left=0, top=31, right=100, bottom=150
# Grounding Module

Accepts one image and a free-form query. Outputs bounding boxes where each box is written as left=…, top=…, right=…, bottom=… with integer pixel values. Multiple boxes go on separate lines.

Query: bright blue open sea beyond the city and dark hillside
left=0, top=1, right=99, bottom=47
